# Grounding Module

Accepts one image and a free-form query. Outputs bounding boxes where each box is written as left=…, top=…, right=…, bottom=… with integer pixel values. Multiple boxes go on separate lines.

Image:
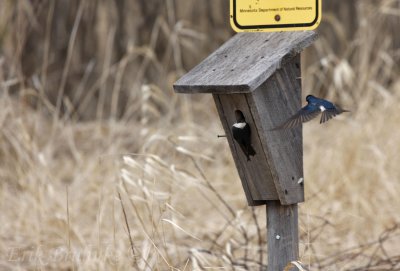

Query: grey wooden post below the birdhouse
left=267, top=201, right=299, bottom=271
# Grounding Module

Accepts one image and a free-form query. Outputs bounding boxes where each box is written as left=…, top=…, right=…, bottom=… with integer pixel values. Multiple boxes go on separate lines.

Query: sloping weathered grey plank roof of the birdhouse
left=174, top=31, right=317, bottom=94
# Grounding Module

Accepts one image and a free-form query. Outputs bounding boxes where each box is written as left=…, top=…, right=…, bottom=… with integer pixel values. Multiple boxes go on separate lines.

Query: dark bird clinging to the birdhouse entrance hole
left=232, top=110, right=256, bottom=161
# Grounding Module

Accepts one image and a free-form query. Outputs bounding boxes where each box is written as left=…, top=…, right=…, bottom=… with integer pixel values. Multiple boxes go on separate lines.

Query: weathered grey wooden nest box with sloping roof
left=174, top=31, right=317, bottom=206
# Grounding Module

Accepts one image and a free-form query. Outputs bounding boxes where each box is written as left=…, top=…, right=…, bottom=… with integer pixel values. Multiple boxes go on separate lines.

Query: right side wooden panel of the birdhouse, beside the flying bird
left=248, top=55, right=304, bottom=205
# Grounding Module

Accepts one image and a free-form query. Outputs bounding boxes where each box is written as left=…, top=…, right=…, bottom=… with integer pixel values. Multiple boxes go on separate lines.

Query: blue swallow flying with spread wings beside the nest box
left=272, top=95, right=350, bottom=131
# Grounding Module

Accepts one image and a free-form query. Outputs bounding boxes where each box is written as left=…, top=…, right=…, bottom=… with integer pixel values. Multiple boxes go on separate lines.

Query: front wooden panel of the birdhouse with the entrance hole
left=213, top=94, right=279, bottom=206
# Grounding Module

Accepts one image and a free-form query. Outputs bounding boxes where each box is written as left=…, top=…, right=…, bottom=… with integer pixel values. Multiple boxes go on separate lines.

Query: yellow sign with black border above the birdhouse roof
left=230, top=0, right=322, bottom=32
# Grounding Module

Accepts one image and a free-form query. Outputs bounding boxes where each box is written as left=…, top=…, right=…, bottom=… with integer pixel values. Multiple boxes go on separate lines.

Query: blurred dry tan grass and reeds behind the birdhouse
left=0, top=0, right=400, bottom=271
